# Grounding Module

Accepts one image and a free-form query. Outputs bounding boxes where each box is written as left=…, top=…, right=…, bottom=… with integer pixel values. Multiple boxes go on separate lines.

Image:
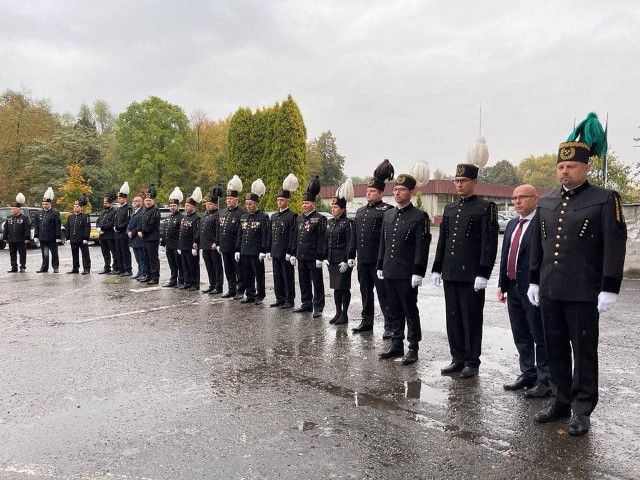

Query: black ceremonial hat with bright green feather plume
left=556, top=112, right=607, bottom=163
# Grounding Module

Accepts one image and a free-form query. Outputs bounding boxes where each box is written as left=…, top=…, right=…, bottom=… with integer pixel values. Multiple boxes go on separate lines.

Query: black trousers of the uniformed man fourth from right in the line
left=384, top=278, right=422, bottom=351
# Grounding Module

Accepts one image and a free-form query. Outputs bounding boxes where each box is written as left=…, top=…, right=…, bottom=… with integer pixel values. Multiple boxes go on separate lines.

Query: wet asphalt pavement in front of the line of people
left=0, top=232, right=640, bottom=480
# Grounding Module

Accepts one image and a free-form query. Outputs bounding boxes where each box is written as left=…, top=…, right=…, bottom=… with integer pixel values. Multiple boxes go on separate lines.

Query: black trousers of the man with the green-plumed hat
left=540, top=298, right=600, bottom=415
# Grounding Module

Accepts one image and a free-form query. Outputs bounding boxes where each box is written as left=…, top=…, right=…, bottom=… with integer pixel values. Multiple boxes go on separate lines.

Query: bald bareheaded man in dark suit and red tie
left=498, top=185, right=551, bottom=398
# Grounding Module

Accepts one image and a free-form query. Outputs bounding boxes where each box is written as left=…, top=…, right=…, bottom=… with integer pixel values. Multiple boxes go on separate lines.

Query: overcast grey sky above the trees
left=0, top=0, right=640, bottom=176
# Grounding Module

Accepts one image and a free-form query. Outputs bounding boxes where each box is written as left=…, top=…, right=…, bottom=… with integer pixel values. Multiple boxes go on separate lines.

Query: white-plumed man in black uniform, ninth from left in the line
left=178, top=187, right=202, bottom=292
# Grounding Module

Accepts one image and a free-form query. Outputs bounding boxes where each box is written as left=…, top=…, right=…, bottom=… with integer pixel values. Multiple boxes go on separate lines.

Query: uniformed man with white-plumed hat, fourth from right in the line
left=376, top=163, right=431, bottom=365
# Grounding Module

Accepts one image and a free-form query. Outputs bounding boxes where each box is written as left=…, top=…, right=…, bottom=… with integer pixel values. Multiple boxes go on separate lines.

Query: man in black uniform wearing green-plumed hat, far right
left=527, top=113, right=627, bottom=435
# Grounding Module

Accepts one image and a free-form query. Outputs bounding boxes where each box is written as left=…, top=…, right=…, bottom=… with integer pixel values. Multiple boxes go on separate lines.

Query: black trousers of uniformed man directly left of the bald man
left=443, top=281, right=485, bottom=367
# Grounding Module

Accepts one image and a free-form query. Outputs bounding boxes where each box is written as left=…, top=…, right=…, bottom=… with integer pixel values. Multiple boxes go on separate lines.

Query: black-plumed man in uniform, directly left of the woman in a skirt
left=289, top=176, right=327, bottom=318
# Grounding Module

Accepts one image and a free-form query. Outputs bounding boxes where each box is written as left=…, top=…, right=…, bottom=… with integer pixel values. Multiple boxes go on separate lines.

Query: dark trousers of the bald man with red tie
left=507, top=282, right=549, bottom=385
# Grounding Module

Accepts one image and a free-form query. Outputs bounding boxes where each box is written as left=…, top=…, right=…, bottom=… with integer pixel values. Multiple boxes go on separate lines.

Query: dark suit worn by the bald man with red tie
left=498, top=214, right=549, bottom=385
